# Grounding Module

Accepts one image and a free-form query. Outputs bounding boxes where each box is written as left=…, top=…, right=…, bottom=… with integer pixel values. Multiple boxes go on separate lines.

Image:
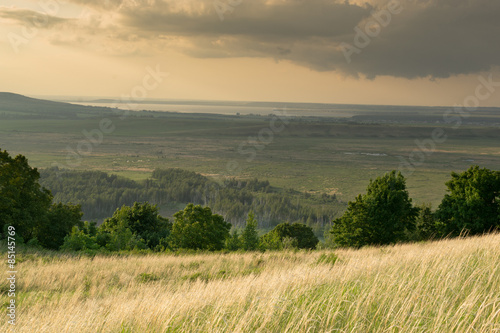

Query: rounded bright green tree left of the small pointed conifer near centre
left=172, top=203, right=231, bottom=251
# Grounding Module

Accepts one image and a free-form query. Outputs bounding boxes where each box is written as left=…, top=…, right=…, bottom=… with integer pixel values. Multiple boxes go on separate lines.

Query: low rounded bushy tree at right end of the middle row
left=261, top=223, right=319, bottom=249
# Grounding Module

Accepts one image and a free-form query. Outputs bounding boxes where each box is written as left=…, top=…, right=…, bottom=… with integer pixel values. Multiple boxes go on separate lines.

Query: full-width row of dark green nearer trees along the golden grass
left=0, top=150, right=500, bottom=253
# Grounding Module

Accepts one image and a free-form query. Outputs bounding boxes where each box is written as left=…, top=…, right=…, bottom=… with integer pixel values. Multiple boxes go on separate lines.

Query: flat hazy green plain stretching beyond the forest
left=0, top=93, right=500, bottom=206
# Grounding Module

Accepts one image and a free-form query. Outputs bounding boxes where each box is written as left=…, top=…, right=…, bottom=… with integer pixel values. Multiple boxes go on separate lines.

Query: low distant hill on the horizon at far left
left=0, top=92, right=111, bottom=118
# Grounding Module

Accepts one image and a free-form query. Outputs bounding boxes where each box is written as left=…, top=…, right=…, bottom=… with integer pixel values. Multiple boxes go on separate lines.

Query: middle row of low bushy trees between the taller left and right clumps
left=60, top=203, right=319, bottom=253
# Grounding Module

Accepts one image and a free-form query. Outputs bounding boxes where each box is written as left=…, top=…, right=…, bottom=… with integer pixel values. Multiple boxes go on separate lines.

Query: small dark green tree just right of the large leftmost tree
left=36, top=203, right=83, bottom=250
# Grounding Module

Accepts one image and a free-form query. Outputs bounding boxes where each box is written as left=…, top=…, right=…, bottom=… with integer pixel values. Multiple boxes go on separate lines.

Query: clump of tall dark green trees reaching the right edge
left=326, top=166, right=500, bottom=248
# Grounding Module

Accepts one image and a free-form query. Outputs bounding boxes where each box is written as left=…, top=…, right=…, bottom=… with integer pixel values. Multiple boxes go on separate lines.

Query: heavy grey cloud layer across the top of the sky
left=0, top=0, right=500, bottom=78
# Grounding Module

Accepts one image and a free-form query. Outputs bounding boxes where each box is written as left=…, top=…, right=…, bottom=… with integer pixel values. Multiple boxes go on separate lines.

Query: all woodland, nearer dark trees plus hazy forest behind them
left=0, top=150, right=500, bottom=252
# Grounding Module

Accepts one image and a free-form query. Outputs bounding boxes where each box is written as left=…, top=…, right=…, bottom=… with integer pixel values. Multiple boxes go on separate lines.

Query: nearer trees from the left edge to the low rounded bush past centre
left=0, top=150, right=319, bottom=253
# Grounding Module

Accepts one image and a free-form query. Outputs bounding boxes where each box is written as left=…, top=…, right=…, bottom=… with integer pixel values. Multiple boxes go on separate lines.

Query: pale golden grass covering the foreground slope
left=0, top=234, right=500, bottom=333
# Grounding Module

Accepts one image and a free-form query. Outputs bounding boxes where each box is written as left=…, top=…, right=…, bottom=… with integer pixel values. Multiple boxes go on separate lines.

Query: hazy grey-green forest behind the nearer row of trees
left=40, top=168, right=345, bottom=234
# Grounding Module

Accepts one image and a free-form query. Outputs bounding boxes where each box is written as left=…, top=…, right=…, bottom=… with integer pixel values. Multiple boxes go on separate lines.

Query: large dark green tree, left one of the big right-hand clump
left=331, top=171, right=418, bottom=247
